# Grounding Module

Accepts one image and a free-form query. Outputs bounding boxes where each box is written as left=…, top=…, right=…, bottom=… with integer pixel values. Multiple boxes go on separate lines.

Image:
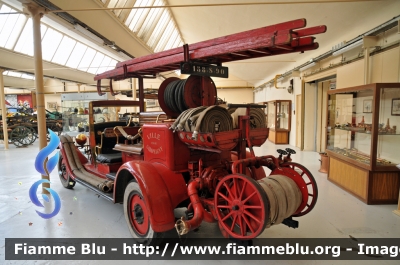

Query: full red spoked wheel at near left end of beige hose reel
left=214, top=174, right=269, bottom=239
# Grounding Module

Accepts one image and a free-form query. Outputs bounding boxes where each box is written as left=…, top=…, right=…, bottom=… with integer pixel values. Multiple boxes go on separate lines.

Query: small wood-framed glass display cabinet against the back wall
left=267, top=100, right=292, bottom=144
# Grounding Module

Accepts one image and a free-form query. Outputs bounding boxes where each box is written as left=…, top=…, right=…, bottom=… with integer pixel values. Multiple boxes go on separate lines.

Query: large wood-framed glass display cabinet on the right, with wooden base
left=326, top=83, right=400, bottom=204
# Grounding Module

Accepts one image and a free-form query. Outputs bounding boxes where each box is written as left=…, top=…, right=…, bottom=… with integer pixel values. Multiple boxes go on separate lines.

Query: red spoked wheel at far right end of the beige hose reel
left=281, top=162, right=318, bottom=217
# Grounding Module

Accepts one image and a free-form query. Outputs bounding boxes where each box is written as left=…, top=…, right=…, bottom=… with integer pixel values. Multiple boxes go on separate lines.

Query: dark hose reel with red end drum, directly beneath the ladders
left=158, top=75, right=217, bottom=118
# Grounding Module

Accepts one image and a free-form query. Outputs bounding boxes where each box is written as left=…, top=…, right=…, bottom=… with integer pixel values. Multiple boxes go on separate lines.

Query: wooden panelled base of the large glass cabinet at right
left=328, top=156, right=400, bottom=204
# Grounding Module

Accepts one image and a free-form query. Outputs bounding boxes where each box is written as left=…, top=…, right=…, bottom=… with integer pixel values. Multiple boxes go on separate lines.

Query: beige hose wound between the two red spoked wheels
left=258, top=175, right=302, bottom=228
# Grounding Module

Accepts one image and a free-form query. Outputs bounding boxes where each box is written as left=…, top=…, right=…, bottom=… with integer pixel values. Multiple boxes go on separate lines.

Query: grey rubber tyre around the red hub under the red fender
left=123, top=180, right=164, bottom=246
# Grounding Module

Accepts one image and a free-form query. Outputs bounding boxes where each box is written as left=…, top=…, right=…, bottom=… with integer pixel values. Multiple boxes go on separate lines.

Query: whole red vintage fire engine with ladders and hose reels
left=58, top=19, right=326, bottom=244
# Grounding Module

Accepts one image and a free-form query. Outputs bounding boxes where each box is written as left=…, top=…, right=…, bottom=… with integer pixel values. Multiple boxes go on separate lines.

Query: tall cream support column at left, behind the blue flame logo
left=24, top=3, right=50, bottom=194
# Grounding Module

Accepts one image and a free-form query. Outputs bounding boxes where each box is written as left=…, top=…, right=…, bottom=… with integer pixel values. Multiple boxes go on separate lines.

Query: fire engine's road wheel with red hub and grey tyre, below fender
left=124, top=181, right=163, bottom=245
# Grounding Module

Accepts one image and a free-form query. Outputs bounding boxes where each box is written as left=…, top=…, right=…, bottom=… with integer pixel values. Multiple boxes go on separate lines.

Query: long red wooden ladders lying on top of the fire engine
left=95, top=19, right=326, bottom=80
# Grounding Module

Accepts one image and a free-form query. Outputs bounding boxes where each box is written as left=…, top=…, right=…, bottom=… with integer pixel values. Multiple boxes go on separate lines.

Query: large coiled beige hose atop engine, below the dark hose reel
left=171, top=106, right=233, bottom=139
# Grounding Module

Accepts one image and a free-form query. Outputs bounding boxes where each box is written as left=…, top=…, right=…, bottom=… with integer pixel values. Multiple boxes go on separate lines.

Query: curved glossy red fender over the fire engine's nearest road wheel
left=115, top=161, right=187, bottom=232
